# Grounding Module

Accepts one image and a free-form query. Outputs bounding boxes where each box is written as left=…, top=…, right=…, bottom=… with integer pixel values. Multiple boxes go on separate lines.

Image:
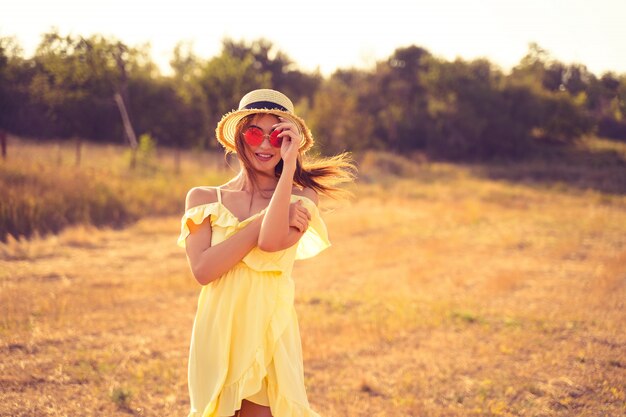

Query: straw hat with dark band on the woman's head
left=215, top=89, right=313, bottom=152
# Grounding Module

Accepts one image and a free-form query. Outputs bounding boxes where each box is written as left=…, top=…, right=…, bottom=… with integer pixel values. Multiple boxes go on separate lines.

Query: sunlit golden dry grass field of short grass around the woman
left=0, top=136, right=626, bottom=417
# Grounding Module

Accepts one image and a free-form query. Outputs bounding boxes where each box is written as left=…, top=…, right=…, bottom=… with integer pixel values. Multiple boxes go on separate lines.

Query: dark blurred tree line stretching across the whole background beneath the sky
left=0, top=31, right=626, bottom=160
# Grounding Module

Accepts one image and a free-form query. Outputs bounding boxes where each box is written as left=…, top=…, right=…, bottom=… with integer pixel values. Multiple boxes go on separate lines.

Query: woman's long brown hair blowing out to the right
left=235, top=114, right=356, bottom=197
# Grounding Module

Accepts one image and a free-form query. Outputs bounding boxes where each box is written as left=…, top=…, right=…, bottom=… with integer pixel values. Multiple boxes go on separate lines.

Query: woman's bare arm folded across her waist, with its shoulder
left=185, top=189, right=263, bottom=285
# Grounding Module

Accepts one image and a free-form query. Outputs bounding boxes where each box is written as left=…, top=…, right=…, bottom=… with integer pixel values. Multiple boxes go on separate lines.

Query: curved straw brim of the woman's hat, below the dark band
left=215, top=109, right=314, bottom=153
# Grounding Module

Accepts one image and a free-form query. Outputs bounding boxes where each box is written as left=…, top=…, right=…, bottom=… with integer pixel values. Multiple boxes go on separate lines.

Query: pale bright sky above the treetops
left=0, top=0, right=626, bottom=75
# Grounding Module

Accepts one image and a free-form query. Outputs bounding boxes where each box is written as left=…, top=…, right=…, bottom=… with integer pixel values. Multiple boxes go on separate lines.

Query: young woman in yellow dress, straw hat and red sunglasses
left=178, top=89, right=354, bottom=417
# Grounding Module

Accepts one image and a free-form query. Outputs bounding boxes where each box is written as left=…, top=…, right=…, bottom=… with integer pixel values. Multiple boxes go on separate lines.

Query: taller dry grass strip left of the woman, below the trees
left=0, top=137, right=229, bottom=242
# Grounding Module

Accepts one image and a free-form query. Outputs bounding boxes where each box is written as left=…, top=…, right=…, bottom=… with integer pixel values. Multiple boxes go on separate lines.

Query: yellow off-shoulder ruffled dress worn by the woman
left=178, top=188, right=330, bottom=417
